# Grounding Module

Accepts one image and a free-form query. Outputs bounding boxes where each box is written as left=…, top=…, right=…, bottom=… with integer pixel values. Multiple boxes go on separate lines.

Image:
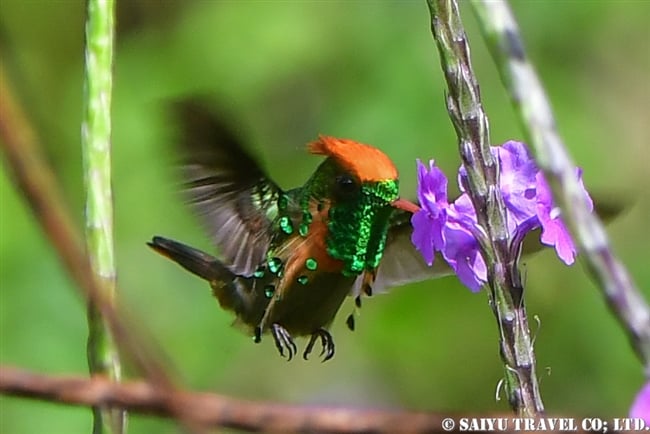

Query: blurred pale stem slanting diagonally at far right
left=472, top=0, right=650, bottom=378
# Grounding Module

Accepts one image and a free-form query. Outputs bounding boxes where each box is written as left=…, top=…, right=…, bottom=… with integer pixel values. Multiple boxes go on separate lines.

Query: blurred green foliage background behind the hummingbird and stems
left=0, top=0, right=650, bottom=433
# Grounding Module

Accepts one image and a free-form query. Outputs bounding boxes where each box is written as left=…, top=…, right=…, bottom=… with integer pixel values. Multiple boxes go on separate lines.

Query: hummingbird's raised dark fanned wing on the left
left=175, top=100, right=282, bottom=276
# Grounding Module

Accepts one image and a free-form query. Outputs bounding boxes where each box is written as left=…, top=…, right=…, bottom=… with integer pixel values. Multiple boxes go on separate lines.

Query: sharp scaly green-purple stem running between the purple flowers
left=427, top=0, right=544, bottom=417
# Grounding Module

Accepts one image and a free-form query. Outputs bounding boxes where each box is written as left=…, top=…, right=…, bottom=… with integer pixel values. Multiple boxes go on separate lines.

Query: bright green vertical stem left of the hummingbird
left=81, top=0, right=126, bottom=434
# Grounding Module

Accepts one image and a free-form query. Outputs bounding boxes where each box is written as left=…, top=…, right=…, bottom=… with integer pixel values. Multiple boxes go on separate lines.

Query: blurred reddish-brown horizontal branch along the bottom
left=0, top=366, right=611, bottom=434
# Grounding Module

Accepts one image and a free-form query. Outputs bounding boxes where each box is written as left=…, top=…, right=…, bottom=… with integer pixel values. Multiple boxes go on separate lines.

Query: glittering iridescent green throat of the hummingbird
left=327, top=180, right=399, bottom=276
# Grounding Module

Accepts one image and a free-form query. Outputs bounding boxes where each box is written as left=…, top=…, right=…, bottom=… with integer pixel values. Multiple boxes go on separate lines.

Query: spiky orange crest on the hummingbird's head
left=308, top=136, right=397, bottom=182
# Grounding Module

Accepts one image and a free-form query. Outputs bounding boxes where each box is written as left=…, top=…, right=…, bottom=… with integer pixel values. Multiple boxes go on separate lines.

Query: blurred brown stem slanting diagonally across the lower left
left=0, top=63, right=203, bottom=432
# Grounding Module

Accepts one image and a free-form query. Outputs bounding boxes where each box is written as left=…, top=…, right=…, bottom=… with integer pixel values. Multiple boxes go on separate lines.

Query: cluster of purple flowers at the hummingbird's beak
left=411, top=141, right=593, bottom=291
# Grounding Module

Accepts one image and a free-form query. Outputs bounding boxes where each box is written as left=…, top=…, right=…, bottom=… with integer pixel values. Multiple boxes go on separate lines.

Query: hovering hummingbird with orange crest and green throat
left=148, top=100, right=451, bottom=361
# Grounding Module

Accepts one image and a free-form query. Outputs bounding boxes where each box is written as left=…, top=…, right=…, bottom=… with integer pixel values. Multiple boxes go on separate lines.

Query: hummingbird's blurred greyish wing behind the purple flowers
left=352, top=210, right=453, bottom=296
